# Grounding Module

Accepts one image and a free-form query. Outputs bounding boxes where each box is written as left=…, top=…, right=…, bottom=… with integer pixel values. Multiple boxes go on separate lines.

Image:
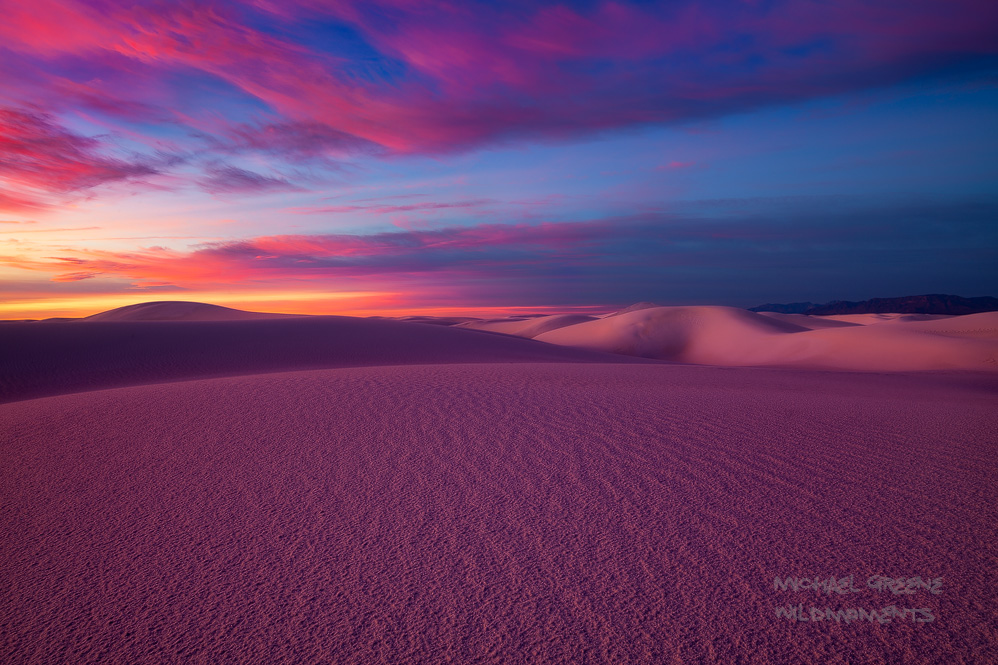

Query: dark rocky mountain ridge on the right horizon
left=749, top=293, right=998, bottom=316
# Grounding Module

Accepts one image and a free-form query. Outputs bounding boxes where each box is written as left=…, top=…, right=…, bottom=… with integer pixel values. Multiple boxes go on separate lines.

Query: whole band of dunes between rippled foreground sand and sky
left=0, top=302, right=998, bottom=401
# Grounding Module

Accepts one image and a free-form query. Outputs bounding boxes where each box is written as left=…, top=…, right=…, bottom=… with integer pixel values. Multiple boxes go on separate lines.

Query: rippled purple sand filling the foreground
left=0, top=364, right=998, bottom=664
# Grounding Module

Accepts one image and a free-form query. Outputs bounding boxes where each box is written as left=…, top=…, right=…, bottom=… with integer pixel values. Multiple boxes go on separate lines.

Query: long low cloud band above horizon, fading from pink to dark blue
left=0, top=200, right=998, bottom=305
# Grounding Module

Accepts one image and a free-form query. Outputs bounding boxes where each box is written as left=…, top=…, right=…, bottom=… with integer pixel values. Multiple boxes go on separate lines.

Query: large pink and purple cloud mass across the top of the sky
left=0, top=0, right=998, bottom=210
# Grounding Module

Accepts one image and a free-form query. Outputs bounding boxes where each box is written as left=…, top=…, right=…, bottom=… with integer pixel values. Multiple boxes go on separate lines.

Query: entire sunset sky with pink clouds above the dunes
left=0, top=0, right=998, bottom=319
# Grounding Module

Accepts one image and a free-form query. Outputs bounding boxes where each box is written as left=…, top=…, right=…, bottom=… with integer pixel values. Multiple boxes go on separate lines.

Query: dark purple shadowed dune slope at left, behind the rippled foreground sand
left=0, top=316, right=648, bottom=402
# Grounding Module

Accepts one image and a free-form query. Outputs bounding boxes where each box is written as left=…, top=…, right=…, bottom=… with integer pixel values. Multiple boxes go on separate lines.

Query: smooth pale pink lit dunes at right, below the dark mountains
left=535, top=306, right=998, bottom=371
